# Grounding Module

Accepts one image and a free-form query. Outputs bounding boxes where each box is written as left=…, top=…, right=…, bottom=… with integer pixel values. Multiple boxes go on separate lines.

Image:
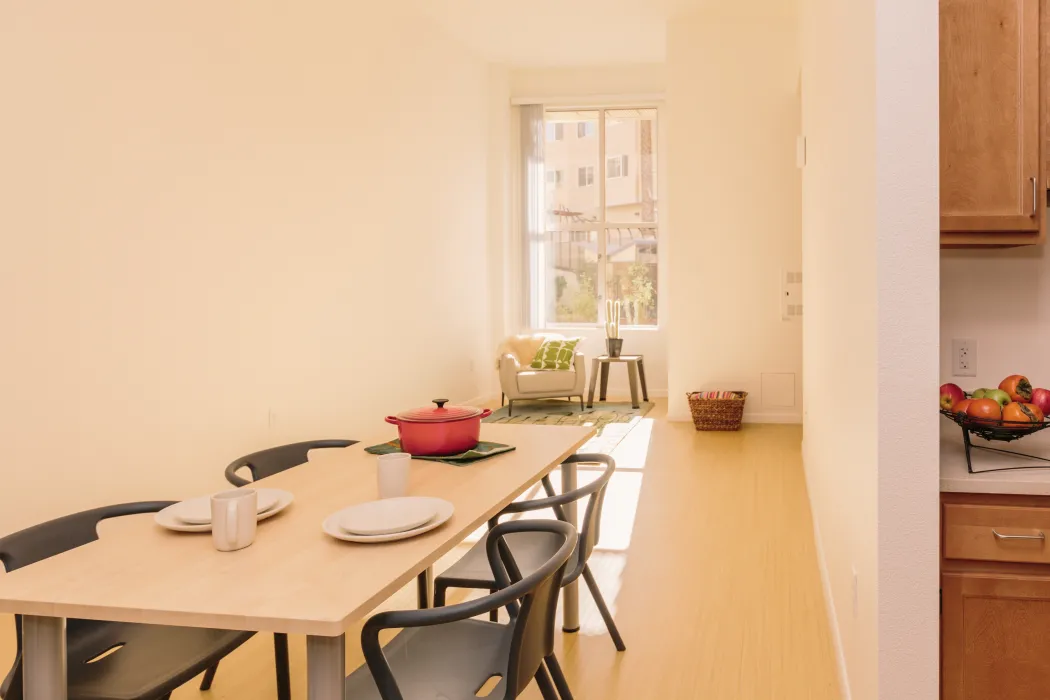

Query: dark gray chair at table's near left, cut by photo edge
left=0, top=502, right=254, bottom=700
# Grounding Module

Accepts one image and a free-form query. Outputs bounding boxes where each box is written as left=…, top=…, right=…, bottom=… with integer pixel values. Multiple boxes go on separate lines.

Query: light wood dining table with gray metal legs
left=0, top=423, right=594, bottom=700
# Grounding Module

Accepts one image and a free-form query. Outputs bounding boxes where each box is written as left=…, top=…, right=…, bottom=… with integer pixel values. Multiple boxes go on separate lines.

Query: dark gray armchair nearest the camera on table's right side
left=343, top=521, right=576, bottom=700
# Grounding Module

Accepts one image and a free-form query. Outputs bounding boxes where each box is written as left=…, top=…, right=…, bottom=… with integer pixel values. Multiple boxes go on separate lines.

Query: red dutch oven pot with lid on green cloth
left=386, top=399, right=492, bottom=457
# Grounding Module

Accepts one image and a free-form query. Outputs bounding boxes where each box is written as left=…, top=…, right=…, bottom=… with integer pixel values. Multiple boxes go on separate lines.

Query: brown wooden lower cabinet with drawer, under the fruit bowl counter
left=941, top=493, right=1050, bottom=700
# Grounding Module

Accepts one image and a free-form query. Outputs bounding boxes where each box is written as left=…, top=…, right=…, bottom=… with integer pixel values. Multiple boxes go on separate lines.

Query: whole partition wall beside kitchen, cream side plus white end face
left=802, top=0, right=939, bottom=700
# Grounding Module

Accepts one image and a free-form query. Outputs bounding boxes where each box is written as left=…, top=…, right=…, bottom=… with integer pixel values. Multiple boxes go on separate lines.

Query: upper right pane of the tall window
left=605, top=109, right=659, bottom=224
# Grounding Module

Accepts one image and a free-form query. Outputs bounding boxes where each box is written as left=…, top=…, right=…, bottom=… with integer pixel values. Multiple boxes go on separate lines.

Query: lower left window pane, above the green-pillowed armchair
left=544, top=231, right=597, bottom=323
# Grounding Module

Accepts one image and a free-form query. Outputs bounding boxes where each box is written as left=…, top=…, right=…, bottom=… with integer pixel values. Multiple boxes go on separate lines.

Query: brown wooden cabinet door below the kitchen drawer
left=941, top=573, right=1050, bottom=700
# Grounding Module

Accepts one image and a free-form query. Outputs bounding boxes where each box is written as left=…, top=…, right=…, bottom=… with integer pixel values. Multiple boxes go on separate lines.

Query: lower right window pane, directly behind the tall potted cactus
left=605, top=226, right=657, bottom=325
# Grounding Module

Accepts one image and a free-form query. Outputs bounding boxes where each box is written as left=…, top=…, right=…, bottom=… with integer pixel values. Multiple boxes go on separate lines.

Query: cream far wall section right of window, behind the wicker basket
left=664, top=8, right=809, bottom=422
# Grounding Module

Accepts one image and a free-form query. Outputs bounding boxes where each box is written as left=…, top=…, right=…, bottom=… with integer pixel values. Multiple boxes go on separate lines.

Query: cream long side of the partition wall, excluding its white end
left=802, top=0, right=879, bottom=700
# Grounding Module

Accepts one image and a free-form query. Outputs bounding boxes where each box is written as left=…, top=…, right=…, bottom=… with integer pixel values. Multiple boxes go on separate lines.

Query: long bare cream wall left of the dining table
left=0, top=0, right=507, bottom=532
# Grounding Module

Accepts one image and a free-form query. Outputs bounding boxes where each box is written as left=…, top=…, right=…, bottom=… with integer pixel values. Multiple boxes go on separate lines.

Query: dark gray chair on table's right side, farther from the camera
left=434, top=454, right=627, bottom=652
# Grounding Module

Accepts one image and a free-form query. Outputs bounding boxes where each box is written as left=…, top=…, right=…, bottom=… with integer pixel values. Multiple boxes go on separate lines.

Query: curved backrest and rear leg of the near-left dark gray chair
left=0, top=501, right=174, bottom=700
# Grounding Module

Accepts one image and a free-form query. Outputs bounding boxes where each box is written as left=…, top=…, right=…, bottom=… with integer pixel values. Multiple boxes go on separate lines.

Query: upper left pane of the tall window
left=544, top=110, right=601, bottom=231
